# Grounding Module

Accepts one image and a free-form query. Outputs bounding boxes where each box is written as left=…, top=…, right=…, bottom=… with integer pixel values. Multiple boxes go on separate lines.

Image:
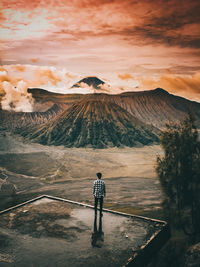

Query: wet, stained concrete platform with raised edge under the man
left=0, top=196, right=169, bottom=267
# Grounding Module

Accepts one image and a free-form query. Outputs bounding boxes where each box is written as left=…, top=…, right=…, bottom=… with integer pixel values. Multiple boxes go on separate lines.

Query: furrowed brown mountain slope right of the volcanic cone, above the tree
left=112, top=88, right=200, bottom=129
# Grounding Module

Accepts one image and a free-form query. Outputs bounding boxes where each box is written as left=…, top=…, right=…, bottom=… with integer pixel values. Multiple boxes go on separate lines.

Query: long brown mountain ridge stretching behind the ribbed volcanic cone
left=3, top=88, right=200, bottom=130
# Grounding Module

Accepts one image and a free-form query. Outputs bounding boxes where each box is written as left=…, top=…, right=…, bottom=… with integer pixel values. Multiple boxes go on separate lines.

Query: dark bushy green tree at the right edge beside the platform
left=156, top=115, right=200, bottom=240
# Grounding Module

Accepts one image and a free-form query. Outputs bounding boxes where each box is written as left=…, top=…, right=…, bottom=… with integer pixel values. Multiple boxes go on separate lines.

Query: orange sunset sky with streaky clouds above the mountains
left=0, top=0, right=200, bottom=101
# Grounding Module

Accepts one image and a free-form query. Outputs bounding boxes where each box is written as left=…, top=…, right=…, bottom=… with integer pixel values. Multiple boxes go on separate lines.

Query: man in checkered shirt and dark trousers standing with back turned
left=93, top=172, right=106, bottom=217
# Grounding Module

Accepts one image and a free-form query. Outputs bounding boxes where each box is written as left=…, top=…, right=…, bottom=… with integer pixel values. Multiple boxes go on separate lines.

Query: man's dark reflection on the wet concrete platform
left=91, top=215, right=104, bottom=248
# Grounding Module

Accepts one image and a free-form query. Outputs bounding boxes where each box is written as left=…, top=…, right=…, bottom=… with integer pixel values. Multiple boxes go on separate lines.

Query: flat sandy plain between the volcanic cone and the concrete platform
left=0, top=132, right=162, bottom=217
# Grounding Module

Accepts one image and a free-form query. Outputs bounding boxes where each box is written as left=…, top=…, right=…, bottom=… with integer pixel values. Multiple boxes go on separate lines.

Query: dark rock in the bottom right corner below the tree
left=185, top=243, right=200, bottom=267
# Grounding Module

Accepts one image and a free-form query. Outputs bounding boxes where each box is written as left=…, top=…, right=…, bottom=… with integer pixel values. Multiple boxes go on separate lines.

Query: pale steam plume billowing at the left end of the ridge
left=1, top=80, right=34, bottom=112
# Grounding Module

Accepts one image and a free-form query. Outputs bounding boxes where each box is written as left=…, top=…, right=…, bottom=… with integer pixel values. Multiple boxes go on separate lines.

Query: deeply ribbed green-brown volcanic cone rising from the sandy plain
left=21, top=99, right=159, bottom=148
